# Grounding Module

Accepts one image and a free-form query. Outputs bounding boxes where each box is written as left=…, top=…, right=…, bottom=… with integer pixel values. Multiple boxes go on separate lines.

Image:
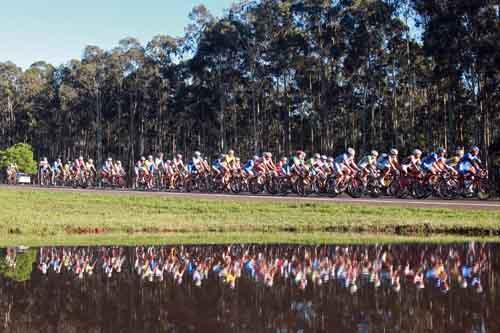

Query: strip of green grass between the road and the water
left=0, top=189, right=500, bottom=246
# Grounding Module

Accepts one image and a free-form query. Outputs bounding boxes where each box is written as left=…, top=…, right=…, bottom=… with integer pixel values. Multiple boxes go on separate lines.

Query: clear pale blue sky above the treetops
left=0, top=0, right=233, bottom=68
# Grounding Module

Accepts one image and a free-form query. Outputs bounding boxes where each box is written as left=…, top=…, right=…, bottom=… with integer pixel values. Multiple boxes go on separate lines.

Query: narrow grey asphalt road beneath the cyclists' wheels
left=0, top=185, right=500, bottom=210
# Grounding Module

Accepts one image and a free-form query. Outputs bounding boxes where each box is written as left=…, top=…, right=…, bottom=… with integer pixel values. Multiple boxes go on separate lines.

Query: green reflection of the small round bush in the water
left=0, top=249, right=36, bottom=282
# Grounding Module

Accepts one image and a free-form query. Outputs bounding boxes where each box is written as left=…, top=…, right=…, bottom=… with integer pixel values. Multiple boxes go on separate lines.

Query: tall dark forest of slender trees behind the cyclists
left=0, top=0, right=500, bottom=171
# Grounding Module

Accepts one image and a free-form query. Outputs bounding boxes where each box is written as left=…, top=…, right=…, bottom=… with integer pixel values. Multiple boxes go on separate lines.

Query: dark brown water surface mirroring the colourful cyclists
left=0, top=243, right=500, bottom=332
